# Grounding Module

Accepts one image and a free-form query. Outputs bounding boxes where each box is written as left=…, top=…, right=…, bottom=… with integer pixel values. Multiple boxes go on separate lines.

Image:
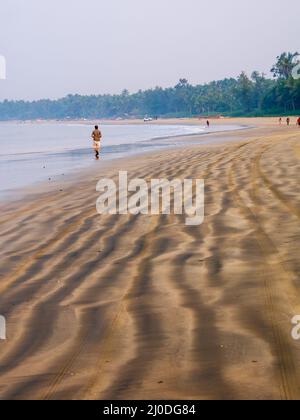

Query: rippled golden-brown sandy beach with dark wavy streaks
left=0, top=118, right=300, bottom=400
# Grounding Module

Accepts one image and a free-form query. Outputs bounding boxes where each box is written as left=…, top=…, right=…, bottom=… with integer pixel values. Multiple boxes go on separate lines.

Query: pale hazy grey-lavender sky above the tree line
left=0, top=0, right=300, bottom=100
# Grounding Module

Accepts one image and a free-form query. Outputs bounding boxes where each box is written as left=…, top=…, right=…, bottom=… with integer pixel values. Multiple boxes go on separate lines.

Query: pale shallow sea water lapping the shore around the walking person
left=0, top=123, right=237, bottom=197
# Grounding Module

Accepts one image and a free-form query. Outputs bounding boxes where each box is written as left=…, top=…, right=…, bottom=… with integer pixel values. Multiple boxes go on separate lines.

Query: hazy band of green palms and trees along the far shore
left=0, top=53, right=300, bottom=120
